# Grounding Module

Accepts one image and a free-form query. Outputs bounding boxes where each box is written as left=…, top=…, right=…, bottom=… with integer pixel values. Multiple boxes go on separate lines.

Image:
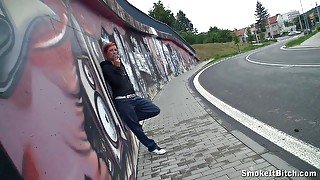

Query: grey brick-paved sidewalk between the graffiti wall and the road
left=137, top=63, right=300, bottom=180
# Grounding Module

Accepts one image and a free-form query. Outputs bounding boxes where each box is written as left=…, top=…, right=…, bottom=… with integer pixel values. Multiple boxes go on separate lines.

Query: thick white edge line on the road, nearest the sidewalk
left=193, top=64, right=320, bottom=169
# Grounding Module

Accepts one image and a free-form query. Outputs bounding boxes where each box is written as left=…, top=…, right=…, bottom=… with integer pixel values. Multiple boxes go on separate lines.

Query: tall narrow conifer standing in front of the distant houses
left=254, top=1, right=269, bottom=38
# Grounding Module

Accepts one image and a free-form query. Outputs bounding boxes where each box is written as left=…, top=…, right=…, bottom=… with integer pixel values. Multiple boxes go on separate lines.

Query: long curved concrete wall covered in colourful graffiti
left=0, top=0, right=196, bottom=180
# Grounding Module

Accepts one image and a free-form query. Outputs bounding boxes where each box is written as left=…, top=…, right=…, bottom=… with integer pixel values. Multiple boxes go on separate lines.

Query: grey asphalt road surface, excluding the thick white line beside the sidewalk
left=199, top=41, right=320, bottom=148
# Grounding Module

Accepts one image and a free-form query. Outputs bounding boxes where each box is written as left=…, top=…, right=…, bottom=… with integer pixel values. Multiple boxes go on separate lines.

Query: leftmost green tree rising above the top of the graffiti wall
left=149, top=0, right=176, bottom=28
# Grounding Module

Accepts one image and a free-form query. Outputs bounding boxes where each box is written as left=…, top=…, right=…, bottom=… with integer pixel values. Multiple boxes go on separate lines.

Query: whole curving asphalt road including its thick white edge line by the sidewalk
left=194, top=42, right=320, bottom=169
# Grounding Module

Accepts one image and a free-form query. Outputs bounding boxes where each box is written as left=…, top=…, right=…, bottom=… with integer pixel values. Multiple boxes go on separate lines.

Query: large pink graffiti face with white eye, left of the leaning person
left=0, top=1, right=135, bottom=179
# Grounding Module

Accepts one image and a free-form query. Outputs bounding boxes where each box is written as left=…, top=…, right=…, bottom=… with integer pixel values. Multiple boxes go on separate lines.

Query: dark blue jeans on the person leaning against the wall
left=114, top=96, right=160, bottom=151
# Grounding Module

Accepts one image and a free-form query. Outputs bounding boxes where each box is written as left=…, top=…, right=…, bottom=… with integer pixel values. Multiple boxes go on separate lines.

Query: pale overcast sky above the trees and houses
left=128, top=0, right=320, bottom=32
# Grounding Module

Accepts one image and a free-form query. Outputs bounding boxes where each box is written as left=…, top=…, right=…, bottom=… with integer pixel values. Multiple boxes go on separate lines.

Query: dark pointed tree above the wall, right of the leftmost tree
left=175, top=10, right=195, bottom=33
